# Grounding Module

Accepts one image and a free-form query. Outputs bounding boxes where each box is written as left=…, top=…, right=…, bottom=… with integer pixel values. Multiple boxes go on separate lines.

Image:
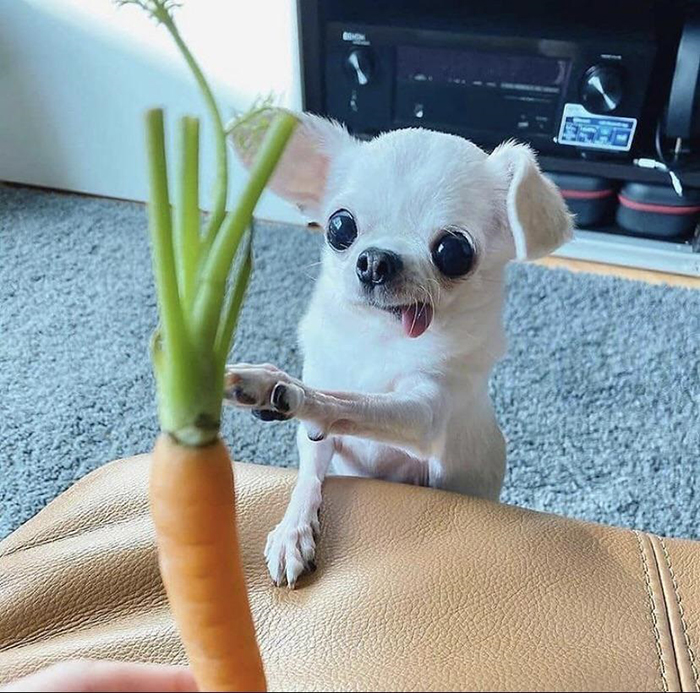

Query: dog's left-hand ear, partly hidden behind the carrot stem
left=229, top=111, right=358, bottom=218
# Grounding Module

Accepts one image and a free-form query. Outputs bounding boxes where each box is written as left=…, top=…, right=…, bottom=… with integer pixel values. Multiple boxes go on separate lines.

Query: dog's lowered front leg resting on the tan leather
left=265, top=426, right=333, bottom=588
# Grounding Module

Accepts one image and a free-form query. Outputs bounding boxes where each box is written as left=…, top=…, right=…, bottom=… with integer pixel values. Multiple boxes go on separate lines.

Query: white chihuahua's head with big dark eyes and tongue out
left=232, top=115, right=572, bottom=337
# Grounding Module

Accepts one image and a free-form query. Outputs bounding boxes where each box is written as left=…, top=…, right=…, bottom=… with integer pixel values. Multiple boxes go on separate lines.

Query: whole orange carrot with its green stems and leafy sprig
left=118, top=0, right=297, bottom=691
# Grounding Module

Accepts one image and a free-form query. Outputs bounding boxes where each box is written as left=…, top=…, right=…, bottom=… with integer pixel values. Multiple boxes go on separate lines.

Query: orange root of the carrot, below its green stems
left=150, top=434, right=266, bottom=691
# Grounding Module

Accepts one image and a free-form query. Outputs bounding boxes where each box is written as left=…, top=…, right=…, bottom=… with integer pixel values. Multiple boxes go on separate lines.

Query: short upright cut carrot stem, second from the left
left=174, top=116, right=200, bottom=313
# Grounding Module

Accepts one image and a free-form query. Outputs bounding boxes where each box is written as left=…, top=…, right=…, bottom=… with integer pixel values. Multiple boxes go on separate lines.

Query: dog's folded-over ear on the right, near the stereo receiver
left=487, top=142, right=573, bottom=260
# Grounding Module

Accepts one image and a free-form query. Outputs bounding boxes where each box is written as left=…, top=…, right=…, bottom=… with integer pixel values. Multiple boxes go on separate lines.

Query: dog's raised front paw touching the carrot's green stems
left=224, top=363, right=304, bottom=421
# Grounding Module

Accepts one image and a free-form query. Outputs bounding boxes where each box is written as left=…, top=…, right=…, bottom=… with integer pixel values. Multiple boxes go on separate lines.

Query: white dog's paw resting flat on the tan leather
left=265, top=519, right=319, bottom=589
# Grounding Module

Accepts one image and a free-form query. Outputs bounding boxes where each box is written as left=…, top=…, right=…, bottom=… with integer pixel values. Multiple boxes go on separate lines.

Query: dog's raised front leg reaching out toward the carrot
left=224, top=364, right=443, bottom=457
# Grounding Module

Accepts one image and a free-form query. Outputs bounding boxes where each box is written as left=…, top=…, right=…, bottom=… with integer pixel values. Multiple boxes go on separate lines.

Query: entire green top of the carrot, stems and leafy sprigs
left=118, top=0, right=297, bottom=446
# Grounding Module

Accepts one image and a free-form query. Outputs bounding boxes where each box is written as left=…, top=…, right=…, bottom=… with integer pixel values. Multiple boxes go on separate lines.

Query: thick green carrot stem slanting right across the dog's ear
left=193, top=111, right=298, bottom=347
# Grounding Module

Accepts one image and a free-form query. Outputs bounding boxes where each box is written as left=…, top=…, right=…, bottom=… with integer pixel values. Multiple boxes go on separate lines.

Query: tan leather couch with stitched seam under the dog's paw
left=0, top=457, right=700, bottom=691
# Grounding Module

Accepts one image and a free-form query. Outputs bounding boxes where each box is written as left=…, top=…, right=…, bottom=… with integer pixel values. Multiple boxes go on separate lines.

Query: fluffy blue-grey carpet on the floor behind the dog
left=0, top=186, right=700, bottom=538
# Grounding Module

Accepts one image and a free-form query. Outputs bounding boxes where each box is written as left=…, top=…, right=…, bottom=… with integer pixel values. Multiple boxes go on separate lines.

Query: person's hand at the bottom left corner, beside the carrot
left=0, top=660, right=197, bottom=693
